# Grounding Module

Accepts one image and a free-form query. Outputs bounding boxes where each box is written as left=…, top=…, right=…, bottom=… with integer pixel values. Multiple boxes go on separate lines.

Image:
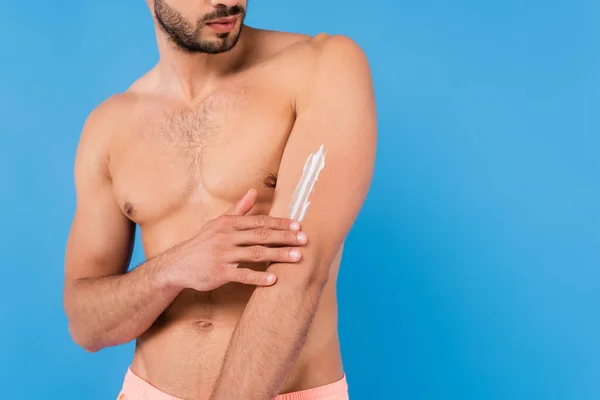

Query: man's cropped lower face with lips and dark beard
left=154, top=0, right=247, bottom=54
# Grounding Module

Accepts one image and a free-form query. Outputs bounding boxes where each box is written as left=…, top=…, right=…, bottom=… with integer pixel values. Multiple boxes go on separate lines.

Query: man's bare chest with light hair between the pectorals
left=110, top=85, right=294, bottom=225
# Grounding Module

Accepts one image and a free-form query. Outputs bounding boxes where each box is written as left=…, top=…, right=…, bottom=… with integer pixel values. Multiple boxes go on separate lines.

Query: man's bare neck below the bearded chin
left=156, top=27, right=249, bottom=103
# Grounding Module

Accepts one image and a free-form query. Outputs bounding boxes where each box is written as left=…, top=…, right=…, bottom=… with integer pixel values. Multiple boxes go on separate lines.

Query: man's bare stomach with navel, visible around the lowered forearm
left=131, top=255, right=344, bottom=399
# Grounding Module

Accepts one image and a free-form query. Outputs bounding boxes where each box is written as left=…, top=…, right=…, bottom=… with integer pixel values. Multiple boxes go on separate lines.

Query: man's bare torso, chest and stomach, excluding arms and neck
left=99, top=27, right=342, bottom=398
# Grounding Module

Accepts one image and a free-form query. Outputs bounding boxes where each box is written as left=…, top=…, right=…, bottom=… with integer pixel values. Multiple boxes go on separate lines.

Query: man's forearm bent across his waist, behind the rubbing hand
left=64, top=255, right=180, bottom=351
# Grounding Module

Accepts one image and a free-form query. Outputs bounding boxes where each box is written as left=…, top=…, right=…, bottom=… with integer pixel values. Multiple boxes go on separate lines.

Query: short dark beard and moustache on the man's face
left=154, top=0, right=246, bottom=54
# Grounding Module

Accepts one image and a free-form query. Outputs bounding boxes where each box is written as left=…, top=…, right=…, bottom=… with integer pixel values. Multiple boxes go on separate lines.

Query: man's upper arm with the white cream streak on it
left=270, top=36, right=377, bottom=282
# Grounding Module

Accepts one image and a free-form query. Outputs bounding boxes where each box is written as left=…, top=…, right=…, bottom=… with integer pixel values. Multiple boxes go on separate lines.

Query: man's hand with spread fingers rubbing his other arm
left=165, top=189, right=307, bottom=291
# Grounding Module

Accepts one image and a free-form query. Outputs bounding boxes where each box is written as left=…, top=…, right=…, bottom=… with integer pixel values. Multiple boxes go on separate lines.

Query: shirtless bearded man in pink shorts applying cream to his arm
left=64, top=0, right=376, bottom=400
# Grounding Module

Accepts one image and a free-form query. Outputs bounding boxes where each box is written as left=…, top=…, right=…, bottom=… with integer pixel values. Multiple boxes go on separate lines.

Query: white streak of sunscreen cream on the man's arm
left=289, top=145, right=327, bottom=222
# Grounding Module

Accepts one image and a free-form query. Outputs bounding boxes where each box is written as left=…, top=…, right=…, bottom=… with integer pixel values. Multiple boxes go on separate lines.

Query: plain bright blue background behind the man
left=0, top=0, right=600, bottom=400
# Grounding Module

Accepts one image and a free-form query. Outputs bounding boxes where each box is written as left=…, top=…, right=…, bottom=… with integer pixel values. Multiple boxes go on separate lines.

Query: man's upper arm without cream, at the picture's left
left=65, top=99, right=134, bottom=290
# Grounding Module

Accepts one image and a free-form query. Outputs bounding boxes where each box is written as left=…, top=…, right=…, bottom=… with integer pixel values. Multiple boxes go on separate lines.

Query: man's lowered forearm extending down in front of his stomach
left=211, top=265, right=324, bottom=400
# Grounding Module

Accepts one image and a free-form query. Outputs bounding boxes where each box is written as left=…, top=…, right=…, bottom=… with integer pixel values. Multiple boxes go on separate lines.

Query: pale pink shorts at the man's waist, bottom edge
left=117, top=368, right=348, bottom=400
